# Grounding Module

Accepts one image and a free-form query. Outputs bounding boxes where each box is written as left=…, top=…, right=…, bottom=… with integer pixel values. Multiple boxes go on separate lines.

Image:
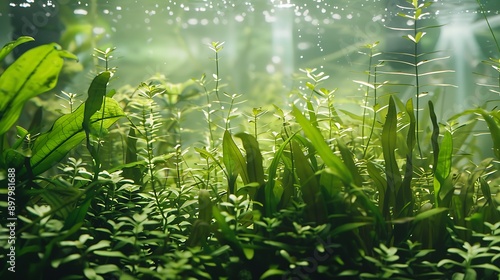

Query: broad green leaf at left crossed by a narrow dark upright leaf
left=26, top=97, right=124, bottom=175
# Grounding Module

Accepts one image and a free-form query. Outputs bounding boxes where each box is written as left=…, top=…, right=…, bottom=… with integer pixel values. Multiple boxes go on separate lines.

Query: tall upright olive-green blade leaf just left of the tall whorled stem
left=381, top=96, right=401, bottom=212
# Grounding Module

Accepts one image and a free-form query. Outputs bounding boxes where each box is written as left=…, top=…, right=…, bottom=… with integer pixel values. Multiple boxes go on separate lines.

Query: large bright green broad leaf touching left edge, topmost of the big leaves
left=0, top=44, right=77, bottom=135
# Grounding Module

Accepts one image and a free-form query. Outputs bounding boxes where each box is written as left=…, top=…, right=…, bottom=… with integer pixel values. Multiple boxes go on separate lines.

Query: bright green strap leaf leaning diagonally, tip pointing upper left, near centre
left=292, top=106, right=353, bottom=185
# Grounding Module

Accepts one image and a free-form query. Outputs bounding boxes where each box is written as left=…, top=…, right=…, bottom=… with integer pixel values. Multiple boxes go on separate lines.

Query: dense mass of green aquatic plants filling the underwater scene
left=0, top=0, right=500, bottom=279
